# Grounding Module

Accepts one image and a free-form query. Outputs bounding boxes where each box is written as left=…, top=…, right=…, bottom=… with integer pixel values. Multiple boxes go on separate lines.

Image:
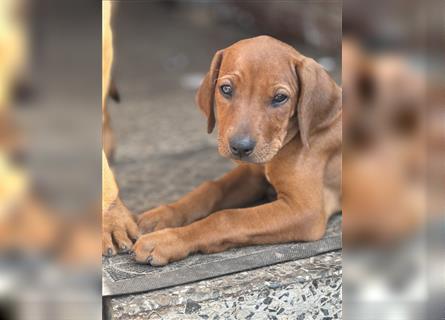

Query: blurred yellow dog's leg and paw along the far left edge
left=0, top=0, right=58, bottom=252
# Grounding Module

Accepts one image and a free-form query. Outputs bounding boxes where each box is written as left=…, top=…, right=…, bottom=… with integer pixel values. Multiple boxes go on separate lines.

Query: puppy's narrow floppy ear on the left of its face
left=196, top=50, right=223, bottom=133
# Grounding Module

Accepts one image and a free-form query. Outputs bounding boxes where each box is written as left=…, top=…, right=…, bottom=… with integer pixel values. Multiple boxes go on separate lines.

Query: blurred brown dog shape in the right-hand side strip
left=342, top=40, right=425, bottom=245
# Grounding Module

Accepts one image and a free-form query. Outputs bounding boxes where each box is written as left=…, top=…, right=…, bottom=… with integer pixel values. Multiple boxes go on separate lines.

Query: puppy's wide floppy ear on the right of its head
left=296, top=58, right=342, bottom=148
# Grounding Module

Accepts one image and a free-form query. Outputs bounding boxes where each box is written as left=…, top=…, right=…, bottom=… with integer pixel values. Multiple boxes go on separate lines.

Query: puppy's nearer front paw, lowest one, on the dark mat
left=133, top=229, right=190, bottom=266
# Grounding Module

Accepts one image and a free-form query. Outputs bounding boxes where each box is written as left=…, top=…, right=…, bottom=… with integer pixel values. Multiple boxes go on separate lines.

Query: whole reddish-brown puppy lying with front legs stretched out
left=133, top=36, right=342, bottom=265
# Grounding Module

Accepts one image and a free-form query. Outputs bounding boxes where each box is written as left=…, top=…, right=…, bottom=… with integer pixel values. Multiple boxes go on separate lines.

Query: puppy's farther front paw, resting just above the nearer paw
left=138, top=205, right=183, bottom=233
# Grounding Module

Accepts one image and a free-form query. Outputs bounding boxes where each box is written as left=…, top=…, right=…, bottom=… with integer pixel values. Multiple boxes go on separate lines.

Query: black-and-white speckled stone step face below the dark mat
left=106, top=252, right=342, bottom=320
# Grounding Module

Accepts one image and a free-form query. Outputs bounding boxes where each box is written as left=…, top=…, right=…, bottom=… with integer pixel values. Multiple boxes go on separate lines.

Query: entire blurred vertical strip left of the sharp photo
left=0, top=0, right=102, bottom=319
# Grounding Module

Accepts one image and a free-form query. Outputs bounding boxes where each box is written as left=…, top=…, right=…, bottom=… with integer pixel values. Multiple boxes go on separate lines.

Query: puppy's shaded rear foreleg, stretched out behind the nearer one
left=138, top=165, right=268, bottom=233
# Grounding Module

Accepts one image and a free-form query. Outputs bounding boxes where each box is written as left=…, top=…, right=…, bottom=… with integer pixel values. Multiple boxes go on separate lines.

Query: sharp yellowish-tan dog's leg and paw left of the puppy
left=102, top=1, right=139, bottom=255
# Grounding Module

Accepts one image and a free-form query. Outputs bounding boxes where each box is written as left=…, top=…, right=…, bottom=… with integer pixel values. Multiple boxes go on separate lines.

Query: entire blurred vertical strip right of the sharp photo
left=342, top=1, right=445, bottom=319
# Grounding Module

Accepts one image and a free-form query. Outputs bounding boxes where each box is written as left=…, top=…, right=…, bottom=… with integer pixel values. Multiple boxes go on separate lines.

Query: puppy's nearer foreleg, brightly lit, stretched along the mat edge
left=133, top=199, right=326, bottom=266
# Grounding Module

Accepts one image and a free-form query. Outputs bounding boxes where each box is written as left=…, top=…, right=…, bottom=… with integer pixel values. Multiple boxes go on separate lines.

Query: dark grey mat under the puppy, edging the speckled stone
left=102, top=214, right=341, bottom=296
